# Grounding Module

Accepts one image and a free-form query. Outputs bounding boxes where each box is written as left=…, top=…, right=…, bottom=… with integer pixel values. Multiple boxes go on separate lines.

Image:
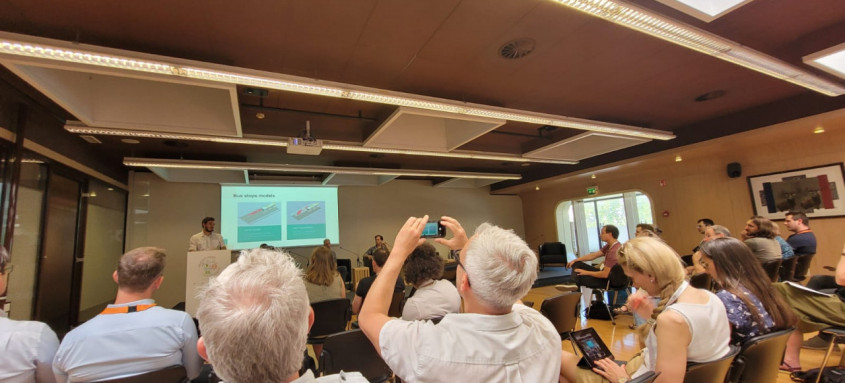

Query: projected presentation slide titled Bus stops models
left=217, top=186, right=340, bottom=250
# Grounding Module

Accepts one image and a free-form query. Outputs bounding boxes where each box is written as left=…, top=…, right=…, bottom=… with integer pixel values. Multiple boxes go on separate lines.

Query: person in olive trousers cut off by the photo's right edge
left=774, top=242, right=845, bottom=371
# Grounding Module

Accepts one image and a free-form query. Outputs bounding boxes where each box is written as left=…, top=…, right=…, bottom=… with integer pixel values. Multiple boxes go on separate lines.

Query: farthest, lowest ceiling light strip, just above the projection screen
left=123, top=157, right=522, bottom=180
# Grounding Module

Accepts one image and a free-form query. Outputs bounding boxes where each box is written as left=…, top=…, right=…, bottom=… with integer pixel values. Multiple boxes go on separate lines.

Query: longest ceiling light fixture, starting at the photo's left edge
left=0, top=32, right=675, bottom=140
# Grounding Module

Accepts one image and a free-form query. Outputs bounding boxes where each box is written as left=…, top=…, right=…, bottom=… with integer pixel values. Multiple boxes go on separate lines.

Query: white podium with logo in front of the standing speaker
left=185, top=250, right=232, bottom=317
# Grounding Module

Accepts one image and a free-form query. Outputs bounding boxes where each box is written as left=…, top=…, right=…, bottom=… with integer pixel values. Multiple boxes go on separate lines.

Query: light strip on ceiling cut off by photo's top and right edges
left=554, top=0, right=845, bottom=96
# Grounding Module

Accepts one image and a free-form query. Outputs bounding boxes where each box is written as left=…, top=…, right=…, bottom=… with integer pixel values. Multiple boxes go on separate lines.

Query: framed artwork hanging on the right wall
left=748, top=163, right=845, bottom=220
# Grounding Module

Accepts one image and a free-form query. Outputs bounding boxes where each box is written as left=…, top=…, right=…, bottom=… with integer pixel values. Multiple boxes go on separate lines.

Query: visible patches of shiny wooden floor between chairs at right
left=523, top=286, right=841, bottom=383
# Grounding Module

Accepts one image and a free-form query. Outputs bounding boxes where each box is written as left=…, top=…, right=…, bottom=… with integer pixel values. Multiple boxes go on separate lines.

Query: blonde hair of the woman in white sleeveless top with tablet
left=618, top=237, right=685, bottom=339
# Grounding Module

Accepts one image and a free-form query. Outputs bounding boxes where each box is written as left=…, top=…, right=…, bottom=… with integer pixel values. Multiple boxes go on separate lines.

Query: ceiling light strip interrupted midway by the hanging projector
left=65, top=124, right=578, bottom=165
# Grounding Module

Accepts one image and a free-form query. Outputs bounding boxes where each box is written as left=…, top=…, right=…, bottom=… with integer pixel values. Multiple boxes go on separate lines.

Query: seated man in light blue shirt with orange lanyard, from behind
left=53, top=247, right=202, bottom=382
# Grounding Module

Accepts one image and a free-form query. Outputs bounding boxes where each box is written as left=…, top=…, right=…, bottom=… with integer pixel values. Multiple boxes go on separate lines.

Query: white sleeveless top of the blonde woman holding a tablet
left=632, top=282, right=731, bottom=378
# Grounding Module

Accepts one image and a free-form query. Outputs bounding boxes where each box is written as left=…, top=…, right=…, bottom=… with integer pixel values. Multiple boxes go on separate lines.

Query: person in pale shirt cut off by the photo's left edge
left=0, top=246, right=59, bottom=383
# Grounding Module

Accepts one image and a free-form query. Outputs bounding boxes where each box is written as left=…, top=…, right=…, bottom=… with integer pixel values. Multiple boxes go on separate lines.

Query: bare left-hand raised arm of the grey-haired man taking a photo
left=358, top=215, right=428, bottom=355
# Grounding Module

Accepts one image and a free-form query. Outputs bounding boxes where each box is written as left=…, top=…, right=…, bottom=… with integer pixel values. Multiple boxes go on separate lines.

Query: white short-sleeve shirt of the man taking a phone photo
left=379, top=304, right=561, bottom=383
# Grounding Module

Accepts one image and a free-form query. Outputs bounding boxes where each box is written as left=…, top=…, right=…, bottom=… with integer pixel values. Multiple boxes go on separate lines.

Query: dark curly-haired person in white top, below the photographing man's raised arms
left=402, top=243, right=461, bottom=321
